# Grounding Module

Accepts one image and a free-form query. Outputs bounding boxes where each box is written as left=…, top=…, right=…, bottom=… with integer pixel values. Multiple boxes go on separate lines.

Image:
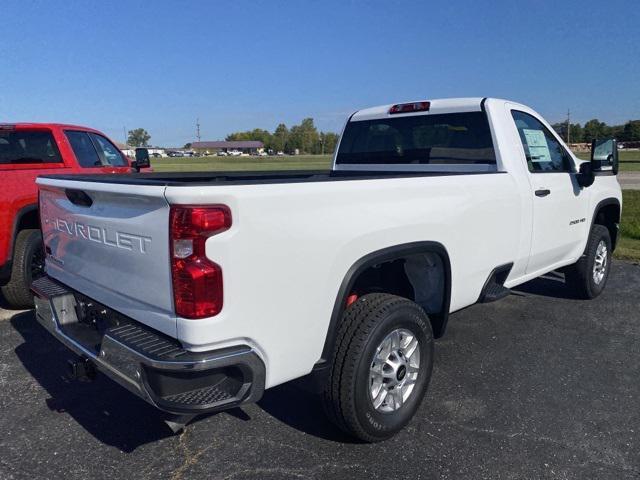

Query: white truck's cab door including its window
left=511, top=110, right=589, bottom=273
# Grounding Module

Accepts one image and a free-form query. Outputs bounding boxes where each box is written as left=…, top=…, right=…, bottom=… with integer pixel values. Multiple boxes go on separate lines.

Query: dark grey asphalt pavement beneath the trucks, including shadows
left=0, top=261, right=640, bottom=480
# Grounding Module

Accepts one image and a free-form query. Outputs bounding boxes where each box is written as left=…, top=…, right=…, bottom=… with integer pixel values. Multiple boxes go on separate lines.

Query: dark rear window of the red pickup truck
left=0, top=130, right=62, bottom=164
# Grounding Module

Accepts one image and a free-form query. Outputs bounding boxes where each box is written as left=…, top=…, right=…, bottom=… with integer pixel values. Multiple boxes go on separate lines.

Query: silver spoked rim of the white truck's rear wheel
left=369, top=328, right=420, bottom=413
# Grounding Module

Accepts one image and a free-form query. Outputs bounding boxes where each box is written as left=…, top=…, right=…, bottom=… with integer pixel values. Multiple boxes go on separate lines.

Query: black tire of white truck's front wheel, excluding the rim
left=565, top=224, right=611, bottom=299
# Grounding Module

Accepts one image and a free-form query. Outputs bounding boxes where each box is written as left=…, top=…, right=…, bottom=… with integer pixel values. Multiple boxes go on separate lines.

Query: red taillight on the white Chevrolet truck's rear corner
left=169, top=205, right=231, bottom=319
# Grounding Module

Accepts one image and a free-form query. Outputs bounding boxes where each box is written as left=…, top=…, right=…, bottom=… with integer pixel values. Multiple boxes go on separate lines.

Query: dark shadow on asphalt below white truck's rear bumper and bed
left=10, top=311, right=348, bottom=453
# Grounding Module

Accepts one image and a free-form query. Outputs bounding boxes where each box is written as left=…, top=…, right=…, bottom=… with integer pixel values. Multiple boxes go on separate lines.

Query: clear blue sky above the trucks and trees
left=0, top=0, right=640, bottom=146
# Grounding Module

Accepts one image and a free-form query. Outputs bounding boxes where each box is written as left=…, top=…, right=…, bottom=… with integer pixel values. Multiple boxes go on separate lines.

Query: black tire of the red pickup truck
left=2, top=229, right=44, bottom=309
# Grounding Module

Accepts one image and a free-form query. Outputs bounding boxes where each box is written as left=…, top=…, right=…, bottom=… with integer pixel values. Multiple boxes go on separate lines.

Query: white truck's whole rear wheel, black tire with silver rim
left=323, top=293, right=433, bottom=442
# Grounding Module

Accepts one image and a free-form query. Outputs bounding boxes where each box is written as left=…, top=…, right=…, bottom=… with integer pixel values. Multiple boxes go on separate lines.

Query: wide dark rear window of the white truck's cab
left=336, top=112, right=496, bottom=165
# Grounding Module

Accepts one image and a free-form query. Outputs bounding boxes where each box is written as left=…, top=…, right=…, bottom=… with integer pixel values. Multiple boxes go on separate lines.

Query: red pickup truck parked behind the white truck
left=0, top=123, right=149, bottom=308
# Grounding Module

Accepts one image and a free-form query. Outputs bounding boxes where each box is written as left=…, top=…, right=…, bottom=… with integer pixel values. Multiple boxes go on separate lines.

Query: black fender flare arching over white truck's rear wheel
left=316, top=241, right=451, bottom=366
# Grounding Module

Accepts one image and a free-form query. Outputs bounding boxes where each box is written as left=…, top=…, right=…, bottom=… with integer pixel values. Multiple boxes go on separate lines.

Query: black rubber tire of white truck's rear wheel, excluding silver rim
left=323, top=293, right=433, bottom=442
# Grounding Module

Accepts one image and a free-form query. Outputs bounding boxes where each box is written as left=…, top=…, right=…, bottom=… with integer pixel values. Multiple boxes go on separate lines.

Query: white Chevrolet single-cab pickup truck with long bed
left=33, top=98, right=621, bottom=441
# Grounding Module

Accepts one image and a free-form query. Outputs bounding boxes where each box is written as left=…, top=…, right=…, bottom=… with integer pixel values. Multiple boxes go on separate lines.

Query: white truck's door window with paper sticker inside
left=511, top=110, right=574, bottom=173
